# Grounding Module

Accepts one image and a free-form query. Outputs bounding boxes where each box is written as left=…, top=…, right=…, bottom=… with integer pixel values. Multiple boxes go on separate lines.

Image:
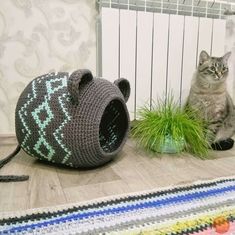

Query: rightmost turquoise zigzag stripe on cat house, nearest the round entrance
left=53, top=94, right=71, bottom=163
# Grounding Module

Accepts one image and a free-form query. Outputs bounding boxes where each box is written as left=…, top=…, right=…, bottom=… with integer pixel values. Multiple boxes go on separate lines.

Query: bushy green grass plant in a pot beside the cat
left=131, top=94, right=210, bottom=158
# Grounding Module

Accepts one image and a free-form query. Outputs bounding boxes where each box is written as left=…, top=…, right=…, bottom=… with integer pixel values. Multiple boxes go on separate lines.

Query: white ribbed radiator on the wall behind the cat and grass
left=100, top=0, right=233, bottom=119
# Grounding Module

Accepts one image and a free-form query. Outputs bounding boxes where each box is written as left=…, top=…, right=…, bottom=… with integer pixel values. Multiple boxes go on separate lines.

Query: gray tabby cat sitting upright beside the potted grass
left=186, top=51, right=235, bottom=150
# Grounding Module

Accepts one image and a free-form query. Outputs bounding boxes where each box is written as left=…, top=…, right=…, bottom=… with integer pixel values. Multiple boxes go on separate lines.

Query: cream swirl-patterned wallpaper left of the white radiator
left=0, top=0, right=97, bottom=134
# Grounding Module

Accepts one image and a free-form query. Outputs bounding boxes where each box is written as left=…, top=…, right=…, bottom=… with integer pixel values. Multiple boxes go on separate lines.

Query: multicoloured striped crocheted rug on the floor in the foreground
left=0, top=177, right=235, bottom=235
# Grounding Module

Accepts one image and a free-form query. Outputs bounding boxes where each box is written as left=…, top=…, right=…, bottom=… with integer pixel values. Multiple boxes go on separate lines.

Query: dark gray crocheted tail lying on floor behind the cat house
left=0, top=145, right=29, bottom=182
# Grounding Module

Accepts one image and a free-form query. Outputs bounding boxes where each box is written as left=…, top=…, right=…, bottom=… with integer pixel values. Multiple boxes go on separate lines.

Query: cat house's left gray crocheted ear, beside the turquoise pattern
left=68, top=69, right=93, bottom=104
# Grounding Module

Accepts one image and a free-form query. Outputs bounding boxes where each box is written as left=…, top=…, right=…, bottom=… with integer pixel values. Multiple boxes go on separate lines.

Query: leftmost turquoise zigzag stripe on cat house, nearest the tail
left=18, top=81, right=37, bottom=150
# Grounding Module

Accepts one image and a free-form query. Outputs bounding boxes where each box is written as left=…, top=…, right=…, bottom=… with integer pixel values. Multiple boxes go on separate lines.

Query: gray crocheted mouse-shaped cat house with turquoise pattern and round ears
left=15, top=70, right=130, bottom=167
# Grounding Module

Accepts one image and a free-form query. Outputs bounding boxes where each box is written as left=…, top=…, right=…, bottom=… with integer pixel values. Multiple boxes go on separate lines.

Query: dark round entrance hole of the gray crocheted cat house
left=99, top=99, right=128, bottom=153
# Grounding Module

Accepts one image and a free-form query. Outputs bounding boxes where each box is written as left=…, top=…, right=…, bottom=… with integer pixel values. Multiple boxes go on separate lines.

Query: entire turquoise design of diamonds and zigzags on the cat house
left=18, top=73, right=72, bottom=164
